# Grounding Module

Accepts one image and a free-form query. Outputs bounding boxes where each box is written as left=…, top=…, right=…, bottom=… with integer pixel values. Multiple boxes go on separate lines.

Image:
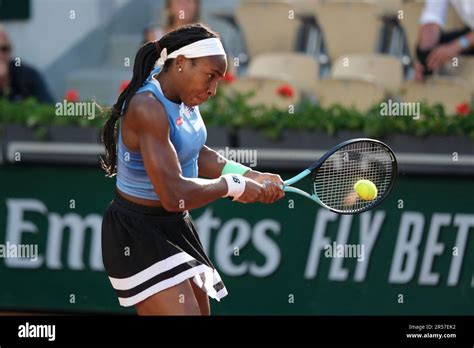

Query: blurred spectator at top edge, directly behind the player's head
left=143, top=0, right=200, bottom=42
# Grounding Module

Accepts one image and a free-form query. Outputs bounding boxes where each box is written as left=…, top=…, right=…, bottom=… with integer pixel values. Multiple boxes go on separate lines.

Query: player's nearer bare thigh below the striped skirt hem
left=135, top=279, right=201, bottom=315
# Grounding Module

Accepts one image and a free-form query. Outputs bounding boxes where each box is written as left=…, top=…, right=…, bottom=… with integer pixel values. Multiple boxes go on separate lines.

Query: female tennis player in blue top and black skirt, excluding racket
left=102, top=24, right=284, bottom=315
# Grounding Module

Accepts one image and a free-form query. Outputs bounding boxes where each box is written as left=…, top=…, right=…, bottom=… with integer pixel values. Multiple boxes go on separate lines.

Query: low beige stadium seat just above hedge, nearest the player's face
left=223, top=77, right=301, bottom=109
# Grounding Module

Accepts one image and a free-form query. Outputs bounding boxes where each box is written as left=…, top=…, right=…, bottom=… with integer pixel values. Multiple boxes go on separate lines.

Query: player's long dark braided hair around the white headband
left=100, top=23, right=219, bottom=177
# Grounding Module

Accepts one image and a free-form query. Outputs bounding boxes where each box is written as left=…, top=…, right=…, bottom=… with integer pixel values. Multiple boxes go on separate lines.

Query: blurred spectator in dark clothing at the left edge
left=0, top=25, right=53, bottom=103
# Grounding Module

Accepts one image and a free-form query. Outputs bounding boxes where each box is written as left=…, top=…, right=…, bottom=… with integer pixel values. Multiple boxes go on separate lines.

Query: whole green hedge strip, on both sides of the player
left=0, top=92, right=474, bottom=139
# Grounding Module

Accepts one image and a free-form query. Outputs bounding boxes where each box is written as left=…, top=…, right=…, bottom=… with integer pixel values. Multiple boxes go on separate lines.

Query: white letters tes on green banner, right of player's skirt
left=196, top=208, right=281, bottom=277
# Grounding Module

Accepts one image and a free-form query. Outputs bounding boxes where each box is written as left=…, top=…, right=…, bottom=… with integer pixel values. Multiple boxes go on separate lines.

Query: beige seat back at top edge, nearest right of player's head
left=236, top=1, right=301, bottom=59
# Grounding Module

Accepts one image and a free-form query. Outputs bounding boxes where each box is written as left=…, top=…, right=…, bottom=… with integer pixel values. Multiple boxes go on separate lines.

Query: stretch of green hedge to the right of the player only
left=201, top=89, right=474, bottom=139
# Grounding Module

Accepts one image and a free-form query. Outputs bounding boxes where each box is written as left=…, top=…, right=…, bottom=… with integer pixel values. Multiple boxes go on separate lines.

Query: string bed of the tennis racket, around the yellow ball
left=313, top=141, right=394, bottom=213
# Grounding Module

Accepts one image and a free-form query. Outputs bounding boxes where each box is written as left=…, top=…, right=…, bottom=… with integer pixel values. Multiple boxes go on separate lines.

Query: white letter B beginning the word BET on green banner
left=389, top=212, right=425, bottom=284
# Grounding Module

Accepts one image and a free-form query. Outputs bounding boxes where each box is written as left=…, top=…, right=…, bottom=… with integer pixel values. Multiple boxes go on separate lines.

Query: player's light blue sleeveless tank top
left=117, top=68, right=207, bottom=200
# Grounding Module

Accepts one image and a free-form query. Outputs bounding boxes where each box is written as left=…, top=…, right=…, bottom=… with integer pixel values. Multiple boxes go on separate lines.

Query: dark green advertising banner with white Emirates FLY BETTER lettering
left=0, top=165, right=474, bottom=315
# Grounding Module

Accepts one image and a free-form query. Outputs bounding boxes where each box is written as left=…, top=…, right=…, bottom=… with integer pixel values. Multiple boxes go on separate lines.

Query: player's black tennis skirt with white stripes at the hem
left=102, top=192, right=227, bottom=307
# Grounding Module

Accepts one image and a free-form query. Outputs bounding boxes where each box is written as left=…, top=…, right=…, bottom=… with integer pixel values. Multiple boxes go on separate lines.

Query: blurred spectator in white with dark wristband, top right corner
left=415, top=0, right=474, bottom=81
